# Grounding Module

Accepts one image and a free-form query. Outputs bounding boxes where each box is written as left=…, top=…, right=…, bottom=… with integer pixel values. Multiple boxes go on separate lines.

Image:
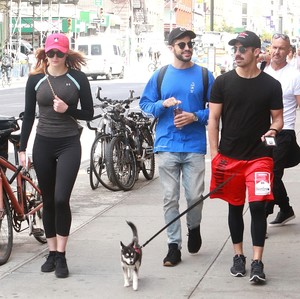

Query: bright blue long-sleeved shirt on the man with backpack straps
left=140, top=64, right=214, bottom=154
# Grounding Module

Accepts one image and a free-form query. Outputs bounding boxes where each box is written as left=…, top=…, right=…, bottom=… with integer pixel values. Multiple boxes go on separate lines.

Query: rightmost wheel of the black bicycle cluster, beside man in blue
left=141, top=128, right=155, bottom=180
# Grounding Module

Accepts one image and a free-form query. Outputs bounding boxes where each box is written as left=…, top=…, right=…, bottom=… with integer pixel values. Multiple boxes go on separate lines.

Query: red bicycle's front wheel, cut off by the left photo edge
left=0, top=190, right=13, bottom=265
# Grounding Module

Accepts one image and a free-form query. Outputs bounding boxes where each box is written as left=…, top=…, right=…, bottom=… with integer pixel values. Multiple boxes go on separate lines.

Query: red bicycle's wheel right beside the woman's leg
left=24, top=163, right=47, bottom=244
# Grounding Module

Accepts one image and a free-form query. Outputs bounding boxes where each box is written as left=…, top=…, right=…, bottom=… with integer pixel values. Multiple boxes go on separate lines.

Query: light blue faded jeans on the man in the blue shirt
left=158, top=152, right=205, bottom=249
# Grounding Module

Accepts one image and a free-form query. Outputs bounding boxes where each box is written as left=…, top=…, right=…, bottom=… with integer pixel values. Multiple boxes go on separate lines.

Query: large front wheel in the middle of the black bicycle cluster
left=107, top=136, right=136, bottom=191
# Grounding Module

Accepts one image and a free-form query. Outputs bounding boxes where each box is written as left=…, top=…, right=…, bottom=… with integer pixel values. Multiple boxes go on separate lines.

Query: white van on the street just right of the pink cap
left=75, top=36, right=124, bottom=80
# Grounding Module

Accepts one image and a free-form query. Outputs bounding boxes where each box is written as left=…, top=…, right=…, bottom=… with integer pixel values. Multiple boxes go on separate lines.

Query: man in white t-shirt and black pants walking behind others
left=264, top=33, right=300, bottom=226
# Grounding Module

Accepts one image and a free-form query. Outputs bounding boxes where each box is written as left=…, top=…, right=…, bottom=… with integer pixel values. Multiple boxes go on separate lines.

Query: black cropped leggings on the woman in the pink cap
left=33, top=135, right=81, bottom=238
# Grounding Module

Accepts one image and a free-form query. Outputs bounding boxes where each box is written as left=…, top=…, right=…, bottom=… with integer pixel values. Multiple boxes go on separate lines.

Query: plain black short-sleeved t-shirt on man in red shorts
left=210, top=70, right=283, bottom=160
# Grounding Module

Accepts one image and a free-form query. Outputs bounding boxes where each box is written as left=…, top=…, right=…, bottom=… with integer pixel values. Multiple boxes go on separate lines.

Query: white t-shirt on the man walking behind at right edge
left=264, top=64, right=300, bottom=130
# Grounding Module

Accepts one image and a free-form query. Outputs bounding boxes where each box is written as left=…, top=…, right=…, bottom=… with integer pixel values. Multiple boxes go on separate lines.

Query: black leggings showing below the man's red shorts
left=228, top=201, right=267, bottom=247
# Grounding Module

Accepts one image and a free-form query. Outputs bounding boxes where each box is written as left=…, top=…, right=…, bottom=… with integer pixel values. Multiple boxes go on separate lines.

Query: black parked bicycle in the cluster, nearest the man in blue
left=106, top=91, right=155, bottom=191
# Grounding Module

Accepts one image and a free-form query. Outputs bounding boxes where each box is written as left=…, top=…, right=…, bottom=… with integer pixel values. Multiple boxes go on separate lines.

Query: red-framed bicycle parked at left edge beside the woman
left=0, top=118, right=46, bottom=265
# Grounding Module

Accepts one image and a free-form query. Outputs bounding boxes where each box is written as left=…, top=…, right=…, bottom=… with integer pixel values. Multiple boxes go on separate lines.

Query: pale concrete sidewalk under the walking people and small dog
left=0, top=71, right=300, bottom=299
